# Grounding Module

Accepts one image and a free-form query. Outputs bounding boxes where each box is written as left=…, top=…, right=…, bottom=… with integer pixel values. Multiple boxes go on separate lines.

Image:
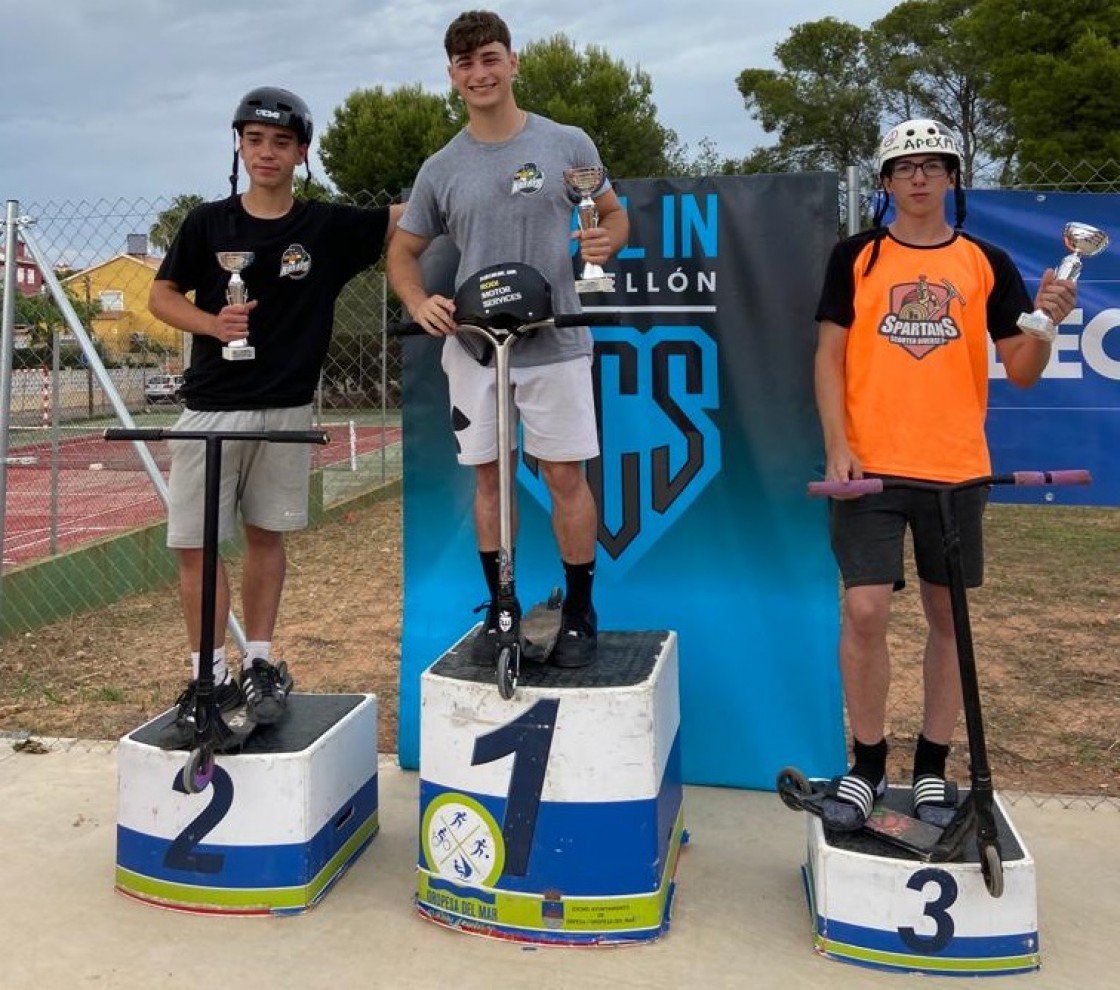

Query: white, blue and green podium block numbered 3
left=802, top=787, right=1039, bottom=977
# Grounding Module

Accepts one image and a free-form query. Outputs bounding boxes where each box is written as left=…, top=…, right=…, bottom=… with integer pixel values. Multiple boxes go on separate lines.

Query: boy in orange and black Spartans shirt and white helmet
left=815, top=120, right=1076, bottom=830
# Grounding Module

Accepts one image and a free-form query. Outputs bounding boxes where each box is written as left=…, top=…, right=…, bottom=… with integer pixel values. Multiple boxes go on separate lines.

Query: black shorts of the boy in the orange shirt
left=829, top=477, right=989, bottom=591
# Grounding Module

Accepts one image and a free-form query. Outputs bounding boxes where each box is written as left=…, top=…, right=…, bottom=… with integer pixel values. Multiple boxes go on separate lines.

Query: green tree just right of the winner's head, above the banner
left=514, top=35, right=678, bottom=178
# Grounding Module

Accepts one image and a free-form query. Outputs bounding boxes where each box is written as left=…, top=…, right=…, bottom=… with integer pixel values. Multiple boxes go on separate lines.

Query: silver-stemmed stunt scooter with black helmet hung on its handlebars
left=386, top=262, right=619, bottom=700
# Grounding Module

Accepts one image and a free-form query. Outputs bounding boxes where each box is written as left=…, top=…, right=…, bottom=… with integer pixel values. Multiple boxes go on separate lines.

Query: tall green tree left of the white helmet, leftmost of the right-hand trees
left=736, top=17, right=886, bottom=170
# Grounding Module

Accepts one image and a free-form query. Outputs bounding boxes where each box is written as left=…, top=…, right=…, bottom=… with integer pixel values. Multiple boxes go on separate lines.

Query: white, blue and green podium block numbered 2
left=116, top=694, right=377, bottom=915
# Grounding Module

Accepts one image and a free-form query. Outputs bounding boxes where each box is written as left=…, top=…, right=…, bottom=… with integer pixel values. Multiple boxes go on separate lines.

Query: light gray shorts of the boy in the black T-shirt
left=167, top=405, right=311, bottom=549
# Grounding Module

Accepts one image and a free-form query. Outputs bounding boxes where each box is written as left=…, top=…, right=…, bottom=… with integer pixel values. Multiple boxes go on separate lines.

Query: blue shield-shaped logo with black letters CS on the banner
left=519, top=326, right=721, bottom=573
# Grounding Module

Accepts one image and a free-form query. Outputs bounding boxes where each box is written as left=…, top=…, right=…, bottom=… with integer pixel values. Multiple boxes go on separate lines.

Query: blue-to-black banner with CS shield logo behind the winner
left=399, top=174, right=844, bottom=790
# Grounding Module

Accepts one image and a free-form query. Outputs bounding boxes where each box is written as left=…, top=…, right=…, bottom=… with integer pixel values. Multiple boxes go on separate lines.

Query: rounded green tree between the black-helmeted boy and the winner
left=319, top=85, right=458, bottom=197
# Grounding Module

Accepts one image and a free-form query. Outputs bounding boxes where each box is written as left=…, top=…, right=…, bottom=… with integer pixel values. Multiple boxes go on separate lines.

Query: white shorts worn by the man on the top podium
left=441, top=340, right=599, bottom=465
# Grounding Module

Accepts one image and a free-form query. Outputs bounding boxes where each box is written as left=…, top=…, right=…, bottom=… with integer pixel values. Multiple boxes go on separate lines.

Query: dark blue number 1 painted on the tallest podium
left=470, top=698, right=560, bottom=877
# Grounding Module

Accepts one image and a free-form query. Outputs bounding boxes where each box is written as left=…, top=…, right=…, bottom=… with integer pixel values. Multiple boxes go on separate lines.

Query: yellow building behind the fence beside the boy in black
left=62, top=245, right=186, bottom=372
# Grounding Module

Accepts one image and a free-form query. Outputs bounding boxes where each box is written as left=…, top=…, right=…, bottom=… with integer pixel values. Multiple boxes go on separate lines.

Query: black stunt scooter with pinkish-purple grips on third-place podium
left=777, top=470, right=1092, bottom=897
